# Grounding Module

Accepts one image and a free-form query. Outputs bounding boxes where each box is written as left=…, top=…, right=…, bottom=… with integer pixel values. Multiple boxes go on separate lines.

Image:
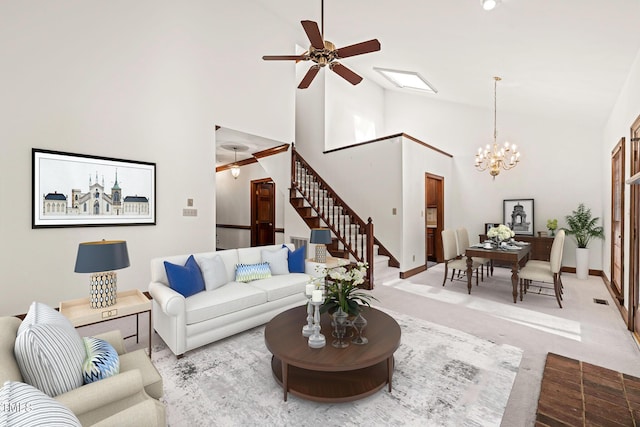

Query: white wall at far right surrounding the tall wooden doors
left=600, top=48, right=640, bottom=309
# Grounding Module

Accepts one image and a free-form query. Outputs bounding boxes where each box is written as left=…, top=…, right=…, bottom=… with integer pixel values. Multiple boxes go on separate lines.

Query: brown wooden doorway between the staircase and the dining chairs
left=424, top=173, right=444, bottom=262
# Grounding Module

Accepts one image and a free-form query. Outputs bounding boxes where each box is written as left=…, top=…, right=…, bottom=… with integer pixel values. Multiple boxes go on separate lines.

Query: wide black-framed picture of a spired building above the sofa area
left=31, top=148, right=156, bottom=228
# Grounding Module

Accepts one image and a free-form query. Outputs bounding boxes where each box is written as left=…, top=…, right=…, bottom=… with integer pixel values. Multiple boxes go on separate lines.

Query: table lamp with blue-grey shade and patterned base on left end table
left=74, top=240, right=130, bottom=308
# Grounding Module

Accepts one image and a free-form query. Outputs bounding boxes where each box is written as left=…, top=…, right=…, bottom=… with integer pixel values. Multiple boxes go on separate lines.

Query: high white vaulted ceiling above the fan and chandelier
left=256, top=0, right=640, bottom=125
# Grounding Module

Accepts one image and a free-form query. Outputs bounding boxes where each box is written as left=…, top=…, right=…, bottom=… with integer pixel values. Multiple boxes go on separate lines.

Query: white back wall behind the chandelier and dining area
left=385, top=91, right=603, bottom=269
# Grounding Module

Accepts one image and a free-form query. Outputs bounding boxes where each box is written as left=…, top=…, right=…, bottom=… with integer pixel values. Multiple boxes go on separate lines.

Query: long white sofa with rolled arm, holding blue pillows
left=149, top=244, right=311, bottom=358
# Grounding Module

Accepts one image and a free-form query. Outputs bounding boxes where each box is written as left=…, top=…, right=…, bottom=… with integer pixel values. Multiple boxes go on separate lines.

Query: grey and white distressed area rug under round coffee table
left=153, top=310, right=522, bottom=427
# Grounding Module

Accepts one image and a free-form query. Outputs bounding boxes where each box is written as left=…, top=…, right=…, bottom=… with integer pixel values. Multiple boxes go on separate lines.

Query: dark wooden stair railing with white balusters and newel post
left=291, top=147, right=374, bottom=289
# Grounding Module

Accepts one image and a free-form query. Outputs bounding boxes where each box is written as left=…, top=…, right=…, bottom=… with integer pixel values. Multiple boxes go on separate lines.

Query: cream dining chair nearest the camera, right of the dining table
left=518, top=230, right=564, bottom=308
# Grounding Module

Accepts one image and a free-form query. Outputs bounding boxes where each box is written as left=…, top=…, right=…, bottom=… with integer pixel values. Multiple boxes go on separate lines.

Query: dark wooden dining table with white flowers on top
left=464, top=242, right=530, bottom=303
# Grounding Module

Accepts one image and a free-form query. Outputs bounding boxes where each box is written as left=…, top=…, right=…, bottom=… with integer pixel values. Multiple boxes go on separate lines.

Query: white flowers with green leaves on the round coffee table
left=320, top=262, right=377, bottom=316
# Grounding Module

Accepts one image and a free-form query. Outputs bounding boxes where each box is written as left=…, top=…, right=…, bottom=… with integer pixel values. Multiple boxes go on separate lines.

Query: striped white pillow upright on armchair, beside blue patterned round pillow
left=14, top=302, right=87, bottom=397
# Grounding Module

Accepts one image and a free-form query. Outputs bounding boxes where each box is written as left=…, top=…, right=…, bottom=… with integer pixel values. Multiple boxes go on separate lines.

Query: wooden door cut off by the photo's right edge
left=627, top=116, right=640, bottom=337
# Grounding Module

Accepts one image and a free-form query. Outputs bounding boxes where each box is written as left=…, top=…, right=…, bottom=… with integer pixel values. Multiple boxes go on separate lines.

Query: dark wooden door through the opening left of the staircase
left=251, top=178, right=276, bottom=246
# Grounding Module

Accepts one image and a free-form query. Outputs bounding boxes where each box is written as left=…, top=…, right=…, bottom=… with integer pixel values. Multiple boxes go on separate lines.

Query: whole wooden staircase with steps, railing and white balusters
left=289, top=148, right=399, bottom=289
